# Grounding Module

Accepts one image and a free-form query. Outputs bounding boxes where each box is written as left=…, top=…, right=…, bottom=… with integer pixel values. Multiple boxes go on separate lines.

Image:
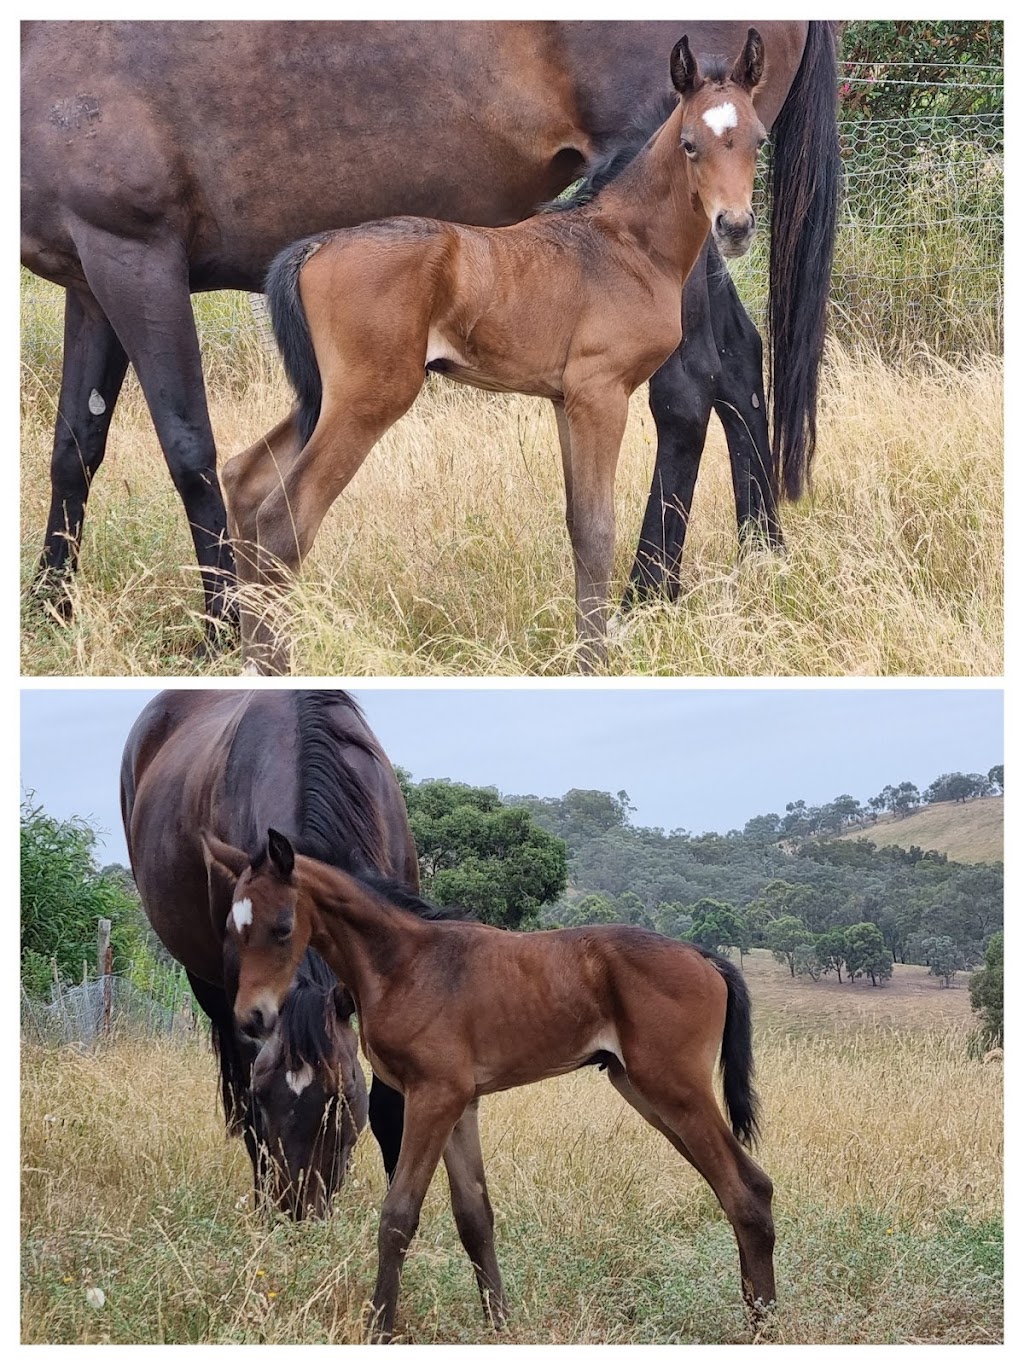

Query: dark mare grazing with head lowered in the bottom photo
left=122, top=691, right=418, bottom=1218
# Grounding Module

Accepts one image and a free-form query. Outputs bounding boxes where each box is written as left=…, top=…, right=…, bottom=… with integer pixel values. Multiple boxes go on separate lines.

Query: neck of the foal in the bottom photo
left=296, top=859, right=429, bottom=1010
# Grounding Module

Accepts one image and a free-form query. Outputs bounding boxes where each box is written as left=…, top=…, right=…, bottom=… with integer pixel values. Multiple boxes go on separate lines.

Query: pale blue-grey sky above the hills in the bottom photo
left=22, top=684, right=1002, bottom=863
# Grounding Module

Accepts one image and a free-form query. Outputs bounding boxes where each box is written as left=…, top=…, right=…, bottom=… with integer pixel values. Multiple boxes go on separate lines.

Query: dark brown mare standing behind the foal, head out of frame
left=22, top=20, right=838, bottom=636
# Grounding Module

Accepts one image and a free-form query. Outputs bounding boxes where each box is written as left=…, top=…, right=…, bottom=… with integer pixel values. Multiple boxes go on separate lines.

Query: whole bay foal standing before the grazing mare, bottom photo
left=208, top=830, right=776, bottom=1338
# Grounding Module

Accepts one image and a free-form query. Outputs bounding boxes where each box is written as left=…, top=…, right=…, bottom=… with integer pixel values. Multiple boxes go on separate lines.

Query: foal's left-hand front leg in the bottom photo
left=370, top=1081, right=471, bottom=1342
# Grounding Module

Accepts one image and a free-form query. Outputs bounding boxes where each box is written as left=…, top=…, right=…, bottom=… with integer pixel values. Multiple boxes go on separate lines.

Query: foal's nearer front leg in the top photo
left=565, top=375, right=629, bottom=673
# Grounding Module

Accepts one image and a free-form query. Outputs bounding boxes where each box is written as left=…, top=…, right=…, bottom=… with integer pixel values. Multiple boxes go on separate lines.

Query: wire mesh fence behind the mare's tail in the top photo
left=733, top=63, right=1004, bottom=360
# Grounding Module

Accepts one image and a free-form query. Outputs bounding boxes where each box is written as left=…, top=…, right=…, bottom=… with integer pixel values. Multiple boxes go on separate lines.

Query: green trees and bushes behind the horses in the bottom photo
left=22, top=767, right=1002, bottom=1029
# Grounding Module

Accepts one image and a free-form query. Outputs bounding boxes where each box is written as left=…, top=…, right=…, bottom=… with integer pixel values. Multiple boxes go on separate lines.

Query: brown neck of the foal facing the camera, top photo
left=594, top=108, right=710, bottom=288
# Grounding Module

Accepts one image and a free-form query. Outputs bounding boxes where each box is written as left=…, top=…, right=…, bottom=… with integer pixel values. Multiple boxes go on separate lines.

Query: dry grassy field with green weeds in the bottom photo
left=22, top=953, right=1002, bottom=1343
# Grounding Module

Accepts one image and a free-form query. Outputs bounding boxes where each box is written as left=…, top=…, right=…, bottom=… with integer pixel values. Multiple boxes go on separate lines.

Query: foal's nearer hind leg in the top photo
left=242, top=363, right=423, bottom=673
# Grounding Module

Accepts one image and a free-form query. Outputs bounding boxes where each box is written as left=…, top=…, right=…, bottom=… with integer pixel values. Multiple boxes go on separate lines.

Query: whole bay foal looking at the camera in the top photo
left=224, top=29, right=765, bottom=672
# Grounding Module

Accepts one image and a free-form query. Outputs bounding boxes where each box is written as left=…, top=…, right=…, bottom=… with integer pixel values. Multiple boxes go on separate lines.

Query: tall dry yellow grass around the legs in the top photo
left=22, top=328, right=1002, bottom=676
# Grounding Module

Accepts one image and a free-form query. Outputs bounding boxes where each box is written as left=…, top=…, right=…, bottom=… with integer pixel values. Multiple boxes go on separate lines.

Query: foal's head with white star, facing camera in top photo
left=670, top=29, right=766, bottom=257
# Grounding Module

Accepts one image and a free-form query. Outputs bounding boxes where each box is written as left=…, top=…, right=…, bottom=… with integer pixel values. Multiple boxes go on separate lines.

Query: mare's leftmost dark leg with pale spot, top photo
left=35, top=288, right=128, bottom=616
